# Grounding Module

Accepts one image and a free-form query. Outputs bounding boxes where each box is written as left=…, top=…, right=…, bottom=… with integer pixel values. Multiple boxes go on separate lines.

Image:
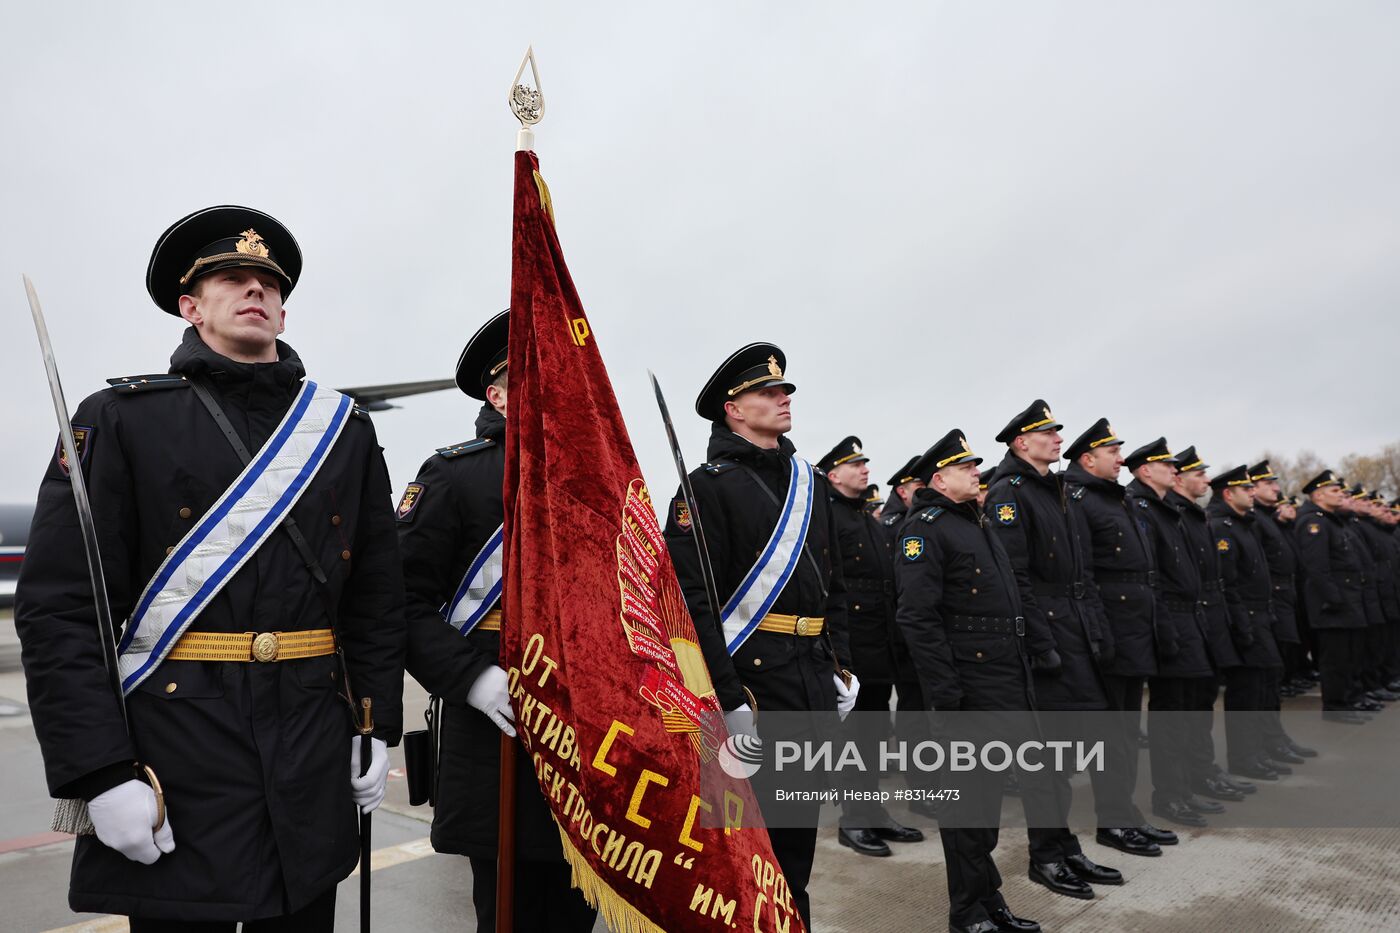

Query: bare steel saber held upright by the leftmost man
left=24, top=276, right=165, bottom=835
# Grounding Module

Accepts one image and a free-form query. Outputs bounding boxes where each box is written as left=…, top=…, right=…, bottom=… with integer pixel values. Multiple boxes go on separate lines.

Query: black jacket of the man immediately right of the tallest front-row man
left=1065, top=464, right=1156, bottom=677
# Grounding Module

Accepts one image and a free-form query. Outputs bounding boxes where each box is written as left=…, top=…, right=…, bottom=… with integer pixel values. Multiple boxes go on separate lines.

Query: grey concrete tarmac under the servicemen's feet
left=0, top=607, right=1400, bottom=933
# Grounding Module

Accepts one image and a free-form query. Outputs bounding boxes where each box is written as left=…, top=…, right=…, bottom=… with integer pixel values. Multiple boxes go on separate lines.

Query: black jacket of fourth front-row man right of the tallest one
left=1205, top=497, right=1284, bottom=671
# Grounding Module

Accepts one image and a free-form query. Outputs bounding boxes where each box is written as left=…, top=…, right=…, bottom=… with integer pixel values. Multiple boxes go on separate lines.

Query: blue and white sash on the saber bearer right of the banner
left=720, top=457, right=813, bottom=654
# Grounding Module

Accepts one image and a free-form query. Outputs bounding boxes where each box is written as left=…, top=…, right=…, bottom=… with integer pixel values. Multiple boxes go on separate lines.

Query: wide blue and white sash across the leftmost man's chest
left=116, top=380, right=354, bottom=693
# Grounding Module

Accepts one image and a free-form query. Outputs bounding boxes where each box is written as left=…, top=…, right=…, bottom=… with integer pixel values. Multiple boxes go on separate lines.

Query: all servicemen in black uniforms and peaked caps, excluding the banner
left=15, top=206, right=1400, bottom=933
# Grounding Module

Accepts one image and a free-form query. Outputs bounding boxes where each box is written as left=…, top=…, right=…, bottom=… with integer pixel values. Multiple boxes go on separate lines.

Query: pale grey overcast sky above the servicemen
left=0, top=0, right=1400, bottom=502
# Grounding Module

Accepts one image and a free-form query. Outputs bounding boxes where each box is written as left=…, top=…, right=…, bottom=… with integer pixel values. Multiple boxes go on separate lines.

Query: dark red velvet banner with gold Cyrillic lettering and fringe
left=501, top=153, right=802, bottom=930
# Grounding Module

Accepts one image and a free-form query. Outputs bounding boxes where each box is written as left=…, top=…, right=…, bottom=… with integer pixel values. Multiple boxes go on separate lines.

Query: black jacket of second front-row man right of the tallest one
left=1127, top=479, right=1211, bottom=677
